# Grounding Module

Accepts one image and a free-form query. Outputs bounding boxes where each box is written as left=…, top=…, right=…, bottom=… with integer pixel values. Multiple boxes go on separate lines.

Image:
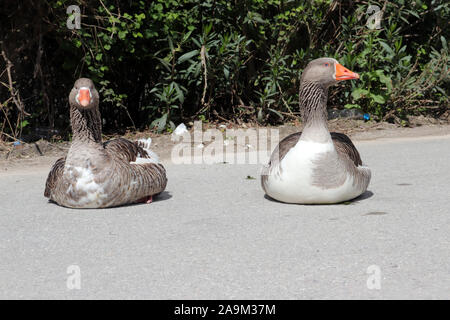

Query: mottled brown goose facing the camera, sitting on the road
left=44, top=78, right=167, bottom=208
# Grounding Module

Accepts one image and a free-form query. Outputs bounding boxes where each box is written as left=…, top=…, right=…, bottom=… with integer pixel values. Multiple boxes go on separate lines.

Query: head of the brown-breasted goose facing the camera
left=69, top=78, right=99, bottom=110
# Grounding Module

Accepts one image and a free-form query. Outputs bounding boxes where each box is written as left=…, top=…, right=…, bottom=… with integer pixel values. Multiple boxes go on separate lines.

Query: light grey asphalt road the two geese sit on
left=0, top=137, right=450, bottom=299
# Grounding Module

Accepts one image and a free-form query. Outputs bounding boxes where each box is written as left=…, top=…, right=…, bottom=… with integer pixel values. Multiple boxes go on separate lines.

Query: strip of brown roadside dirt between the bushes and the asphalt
left=0, top=117, right=450, bottom=176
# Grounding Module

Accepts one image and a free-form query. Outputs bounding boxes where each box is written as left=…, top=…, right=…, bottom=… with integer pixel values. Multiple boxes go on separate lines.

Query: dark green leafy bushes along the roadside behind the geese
left=0, top=0, right=450, bottom=140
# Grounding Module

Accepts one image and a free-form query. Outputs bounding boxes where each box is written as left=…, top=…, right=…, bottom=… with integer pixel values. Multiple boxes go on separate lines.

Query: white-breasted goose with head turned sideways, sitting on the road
left=261, top=58, right=371, bottom=204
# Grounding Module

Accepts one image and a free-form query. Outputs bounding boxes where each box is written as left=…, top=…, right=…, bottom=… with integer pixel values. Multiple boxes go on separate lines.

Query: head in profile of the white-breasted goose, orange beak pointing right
left=301, top=58, right=359, bottom=87
